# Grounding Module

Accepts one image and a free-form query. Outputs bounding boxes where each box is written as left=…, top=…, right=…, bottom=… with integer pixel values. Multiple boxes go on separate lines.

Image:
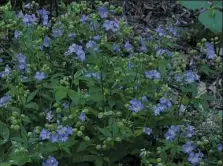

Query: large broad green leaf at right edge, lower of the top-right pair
left=198, top=10, right=222, bottom=32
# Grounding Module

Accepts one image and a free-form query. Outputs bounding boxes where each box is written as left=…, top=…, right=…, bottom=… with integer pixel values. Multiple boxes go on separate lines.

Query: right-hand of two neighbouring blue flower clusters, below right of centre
left=154, top=97, right=172, bottom=116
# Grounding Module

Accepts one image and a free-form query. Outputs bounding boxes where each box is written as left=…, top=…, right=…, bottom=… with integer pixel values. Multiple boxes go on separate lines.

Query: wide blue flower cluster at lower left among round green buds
left=40, top=126, right=73, bottom=143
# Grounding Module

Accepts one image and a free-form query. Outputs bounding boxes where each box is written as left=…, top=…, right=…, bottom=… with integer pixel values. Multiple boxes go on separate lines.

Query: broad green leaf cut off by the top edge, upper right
left=178, top=0, right=210, bottom=10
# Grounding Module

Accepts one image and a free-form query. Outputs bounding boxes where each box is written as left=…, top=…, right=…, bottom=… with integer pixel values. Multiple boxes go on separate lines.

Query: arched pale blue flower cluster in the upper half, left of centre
left=64, top=44, right=85, bottom=61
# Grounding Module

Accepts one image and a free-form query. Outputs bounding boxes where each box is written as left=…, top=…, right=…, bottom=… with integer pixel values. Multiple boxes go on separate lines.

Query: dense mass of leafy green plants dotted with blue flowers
left=0, top=1, right=222, bottom=166
